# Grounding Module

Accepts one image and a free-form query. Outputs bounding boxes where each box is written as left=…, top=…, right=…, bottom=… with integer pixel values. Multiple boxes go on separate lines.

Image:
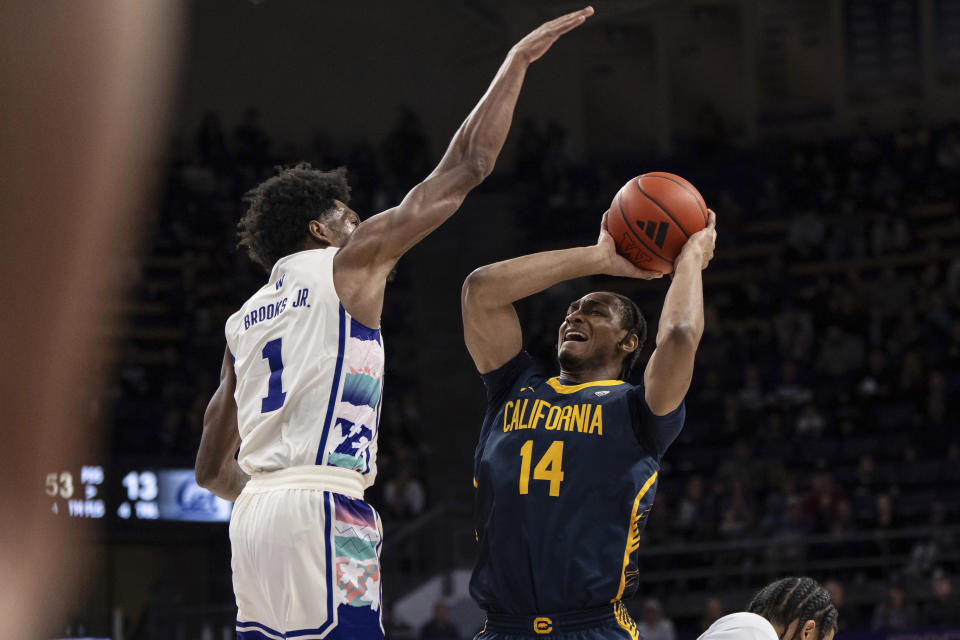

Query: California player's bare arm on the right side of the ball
left=643, top=211, right=717, bottom=416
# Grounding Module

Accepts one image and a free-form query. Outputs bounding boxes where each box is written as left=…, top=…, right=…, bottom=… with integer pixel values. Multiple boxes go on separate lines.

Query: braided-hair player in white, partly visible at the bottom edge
left=698, top=577, right=837, bottom=640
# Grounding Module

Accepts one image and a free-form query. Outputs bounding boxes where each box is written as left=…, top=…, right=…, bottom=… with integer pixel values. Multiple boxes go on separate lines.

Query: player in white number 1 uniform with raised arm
left=196, top=7, right=593, bottom=640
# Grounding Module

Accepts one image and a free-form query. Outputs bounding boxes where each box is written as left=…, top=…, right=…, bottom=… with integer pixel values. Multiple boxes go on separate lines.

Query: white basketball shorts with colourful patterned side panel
left=230, top=466, right=383, bottom=640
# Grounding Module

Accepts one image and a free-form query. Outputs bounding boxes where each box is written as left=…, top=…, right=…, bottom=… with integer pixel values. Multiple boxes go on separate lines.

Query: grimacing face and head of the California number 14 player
left=557, top=293, right=627, bottom=370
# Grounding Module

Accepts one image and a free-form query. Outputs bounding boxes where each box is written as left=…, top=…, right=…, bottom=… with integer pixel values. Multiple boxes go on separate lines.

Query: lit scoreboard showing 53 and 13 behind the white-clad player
left=44, top=464, right=233, bottom=522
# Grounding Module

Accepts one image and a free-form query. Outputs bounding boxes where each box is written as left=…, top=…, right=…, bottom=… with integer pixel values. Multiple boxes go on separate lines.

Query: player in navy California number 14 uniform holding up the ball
left=462, top=211, right=716, bottom=640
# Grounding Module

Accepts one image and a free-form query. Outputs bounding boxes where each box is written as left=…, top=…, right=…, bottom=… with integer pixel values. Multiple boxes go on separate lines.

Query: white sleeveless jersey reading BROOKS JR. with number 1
left=226, top=248, right=384, bottom=487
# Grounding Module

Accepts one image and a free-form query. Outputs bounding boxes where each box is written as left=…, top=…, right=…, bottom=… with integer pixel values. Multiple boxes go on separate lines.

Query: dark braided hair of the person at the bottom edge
left=747, top=577, right=837, bottom=640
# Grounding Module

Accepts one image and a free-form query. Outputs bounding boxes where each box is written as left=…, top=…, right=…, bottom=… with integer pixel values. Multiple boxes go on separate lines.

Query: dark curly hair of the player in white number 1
left=237, top=162, right=350, bottom=272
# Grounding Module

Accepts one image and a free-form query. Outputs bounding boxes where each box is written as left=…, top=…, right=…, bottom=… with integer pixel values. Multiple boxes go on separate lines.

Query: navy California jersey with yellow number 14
left=470, top=351, right=686, bottom=615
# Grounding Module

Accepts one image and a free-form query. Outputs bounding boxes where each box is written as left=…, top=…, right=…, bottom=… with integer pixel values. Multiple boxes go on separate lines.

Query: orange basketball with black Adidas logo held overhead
left=607, top=171, right=708, bottom=273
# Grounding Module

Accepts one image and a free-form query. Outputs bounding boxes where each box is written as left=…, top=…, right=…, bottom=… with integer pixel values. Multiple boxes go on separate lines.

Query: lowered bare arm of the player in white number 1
left=195, top=349, right=250, bottom=502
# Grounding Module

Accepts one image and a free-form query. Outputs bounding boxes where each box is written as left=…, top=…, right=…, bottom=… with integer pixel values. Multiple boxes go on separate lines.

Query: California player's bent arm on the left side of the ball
left=460, top=214, right=662, bottom=373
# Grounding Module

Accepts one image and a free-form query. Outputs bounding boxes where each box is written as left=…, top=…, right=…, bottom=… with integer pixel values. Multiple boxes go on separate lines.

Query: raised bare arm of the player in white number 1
left=334, top=7, right=593, bottom=326
